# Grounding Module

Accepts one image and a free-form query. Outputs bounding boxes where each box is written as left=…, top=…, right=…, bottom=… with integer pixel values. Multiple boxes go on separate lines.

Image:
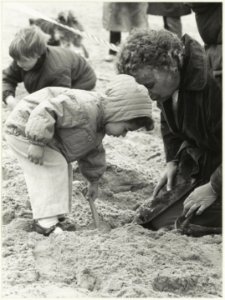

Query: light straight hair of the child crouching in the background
left=9, top=26, right=47, bottom=60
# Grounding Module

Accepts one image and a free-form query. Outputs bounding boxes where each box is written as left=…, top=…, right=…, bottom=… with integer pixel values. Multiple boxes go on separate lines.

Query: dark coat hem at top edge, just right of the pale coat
left=147, top=2, right=191, bottom=17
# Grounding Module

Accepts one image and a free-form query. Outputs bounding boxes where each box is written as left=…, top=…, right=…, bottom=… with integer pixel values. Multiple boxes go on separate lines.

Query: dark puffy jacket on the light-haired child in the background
left=2, top=46, right=96, bottom=101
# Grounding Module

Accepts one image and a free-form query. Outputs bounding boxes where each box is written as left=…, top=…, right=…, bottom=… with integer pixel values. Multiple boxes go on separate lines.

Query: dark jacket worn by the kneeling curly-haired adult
left=160, top=34, right=222, bottom=193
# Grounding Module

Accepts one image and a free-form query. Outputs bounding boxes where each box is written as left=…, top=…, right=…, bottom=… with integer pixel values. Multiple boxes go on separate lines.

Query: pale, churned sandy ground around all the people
left=2, top=2, right=222, bottom=298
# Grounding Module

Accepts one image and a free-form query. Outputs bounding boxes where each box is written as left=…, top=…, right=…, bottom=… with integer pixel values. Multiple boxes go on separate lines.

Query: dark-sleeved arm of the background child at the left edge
left=2, top=61, right=23, bottom=104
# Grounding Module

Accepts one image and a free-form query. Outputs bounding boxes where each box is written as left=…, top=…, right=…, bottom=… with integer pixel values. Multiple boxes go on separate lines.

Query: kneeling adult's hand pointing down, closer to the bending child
left=153, top=161, right=177, bottom=198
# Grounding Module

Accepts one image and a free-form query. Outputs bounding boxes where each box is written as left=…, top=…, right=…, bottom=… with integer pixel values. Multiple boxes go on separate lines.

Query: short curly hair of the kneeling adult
left=116, top=29, right=184, bottom=76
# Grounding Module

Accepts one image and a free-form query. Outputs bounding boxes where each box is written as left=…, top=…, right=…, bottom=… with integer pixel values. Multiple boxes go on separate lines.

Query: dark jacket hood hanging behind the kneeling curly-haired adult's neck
left=181, top=34, right=208, bottom=91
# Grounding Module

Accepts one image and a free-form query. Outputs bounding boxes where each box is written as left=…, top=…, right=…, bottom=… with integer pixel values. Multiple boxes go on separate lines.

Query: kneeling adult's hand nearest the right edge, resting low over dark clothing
left=183, top=182, right=217, bottom=217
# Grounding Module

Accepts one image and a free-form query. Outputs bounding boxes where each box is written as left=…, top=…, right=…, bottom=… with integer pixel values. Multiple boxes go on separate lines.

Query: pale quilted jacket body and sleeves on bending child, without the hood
left=5, top=87, right=105, bottom=181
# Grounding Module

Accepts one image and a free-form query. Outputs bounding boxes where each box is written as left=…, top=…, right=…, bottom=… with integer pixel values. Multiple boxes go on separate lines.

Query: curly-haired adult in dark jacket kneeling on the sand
left=117, top=30, right=222, bottom=234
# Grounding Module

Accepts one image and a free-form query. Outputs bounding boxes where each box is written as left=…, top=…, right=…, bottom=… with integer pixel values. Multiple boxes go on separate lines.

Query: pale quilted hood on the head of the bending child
left=103, top=74, right=152, bottom=123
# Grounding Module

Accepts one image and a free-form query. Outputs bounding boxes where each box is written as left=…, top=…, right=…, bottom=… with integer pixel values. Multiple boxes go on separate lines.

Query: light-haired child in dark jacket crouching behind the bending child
left=2, top=26, right=96, bottom=108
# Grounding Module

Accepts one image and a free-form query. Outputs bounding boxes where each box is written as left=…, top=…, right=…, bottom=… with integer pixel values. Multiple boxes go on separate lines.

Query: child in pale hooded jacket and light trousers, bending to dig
left=5, top=75, right=153, bottom=235
